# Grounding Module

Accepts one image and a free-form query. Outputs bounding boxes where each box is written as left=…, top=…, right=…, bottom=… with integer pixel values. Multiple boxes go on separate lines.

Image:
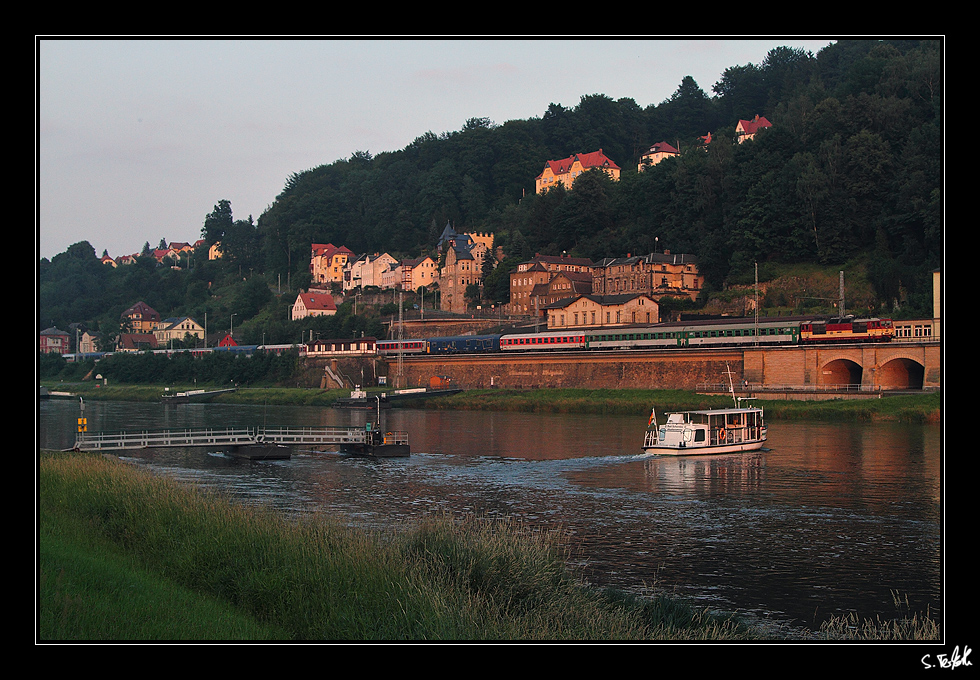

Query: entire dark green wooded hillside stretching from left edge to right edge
left=37, top=40, right=943, bottom=350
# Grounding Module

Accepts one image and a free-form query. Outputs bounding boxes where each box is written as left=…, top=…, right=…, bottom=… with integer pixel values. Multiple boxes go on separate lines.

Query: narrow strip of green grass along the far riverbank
left=47, top=383, right=943, bottom=423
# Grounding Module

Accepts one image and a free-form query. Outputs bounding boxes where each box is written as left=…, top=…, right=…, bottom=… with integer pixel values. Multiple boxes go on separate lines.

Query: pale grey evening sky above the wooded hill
left=35, top=36, right=832, bottom=259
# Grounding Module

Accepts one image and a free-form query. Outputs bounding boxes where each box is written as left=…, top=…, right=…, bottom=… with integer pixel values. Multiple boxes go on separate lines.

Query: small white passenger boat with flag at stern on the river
left=643, top=370, right=768, bottom=456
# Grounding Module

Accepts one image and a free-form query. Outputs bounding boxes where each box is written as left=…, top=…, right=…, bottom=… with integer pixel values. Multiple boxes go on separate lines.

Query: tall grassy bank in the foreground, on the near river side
left=37, top=452, right=939, bottom=642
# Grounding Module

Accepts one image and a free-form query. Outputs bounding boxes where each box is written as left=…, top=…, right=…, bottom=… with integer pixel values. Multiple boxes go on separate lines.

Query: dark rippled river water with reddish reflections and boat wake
left=37, top=400, right=943, bottom=628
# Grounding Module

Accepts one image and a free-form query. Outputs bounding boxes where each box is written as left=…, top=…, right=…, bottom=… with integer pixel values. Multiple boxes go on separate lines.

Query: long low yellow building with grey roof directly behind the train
left=545, top=295, right=660, bottom=330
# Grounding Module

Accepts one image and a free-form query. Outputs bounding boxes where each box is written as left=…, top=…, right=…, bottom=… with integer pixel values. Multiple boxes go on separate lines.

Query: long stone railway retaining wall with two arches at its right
left=388, top=342, right=942, bottom=398
